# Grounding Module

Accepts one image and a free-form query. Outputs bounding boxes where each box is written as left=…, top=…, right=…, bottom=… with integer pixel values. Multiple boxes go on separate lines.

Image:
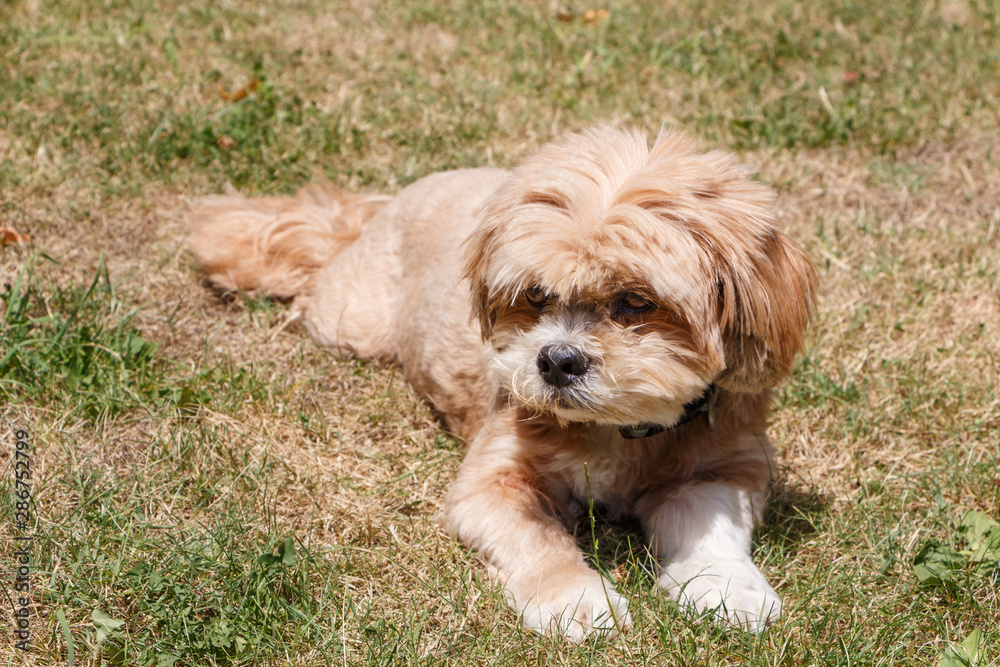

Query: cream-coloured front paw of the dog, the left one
left=505, top=564, right=632, bottom=642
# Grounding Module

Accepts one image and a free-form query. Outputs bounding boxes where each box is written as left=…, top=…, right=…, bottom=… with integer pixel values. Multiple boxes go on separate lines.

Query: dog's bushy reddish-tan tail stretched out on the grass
left=188, top=183, right=390, bottom=299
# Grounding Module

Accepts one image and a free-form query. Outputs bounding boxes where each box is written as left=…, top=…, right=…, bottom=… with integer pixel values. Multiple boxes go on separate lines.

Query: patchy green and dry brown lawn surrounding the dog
left=0, top=0, right=1000, bottom=666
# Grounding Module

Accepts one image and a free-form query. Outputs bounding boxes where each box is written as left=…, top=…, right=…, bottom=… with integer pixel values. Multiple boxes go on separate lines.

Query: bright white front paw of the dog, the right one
left=660, top=558, right=781, bottom=632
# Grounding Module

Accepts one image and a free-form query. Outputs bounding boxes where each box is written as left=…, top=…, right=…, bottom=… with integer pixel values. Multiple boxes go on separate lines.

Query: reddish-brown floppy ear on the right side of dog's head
left=716, top=229, right=817, bottom=393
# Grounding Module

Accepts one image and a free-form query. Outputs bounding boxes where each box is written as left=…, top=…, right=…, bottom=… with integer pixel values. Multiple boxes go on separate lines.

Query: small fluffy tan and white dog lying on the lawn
left=190, top=126, right=817, bottom=641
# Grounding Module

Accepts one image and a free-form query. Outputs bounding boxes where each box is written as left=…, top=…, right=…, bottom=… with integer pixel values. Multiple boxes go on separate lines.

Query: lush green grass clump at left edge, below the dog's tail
left=0, top=258, right=274, bottom=421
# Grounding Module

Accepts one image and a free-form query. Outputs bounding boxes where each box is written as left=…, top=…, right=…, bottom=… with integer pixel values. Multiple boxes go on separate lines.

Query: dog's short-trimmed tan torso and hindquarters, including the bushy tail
left=188, top=169, right=507, bottom=437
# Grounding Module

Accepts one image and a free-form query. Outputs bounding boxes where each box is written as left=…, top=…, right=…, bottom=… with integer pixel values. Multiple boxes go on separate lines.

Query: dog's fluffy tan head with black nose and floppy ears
left=466, top=126, right=816, bottom=426
